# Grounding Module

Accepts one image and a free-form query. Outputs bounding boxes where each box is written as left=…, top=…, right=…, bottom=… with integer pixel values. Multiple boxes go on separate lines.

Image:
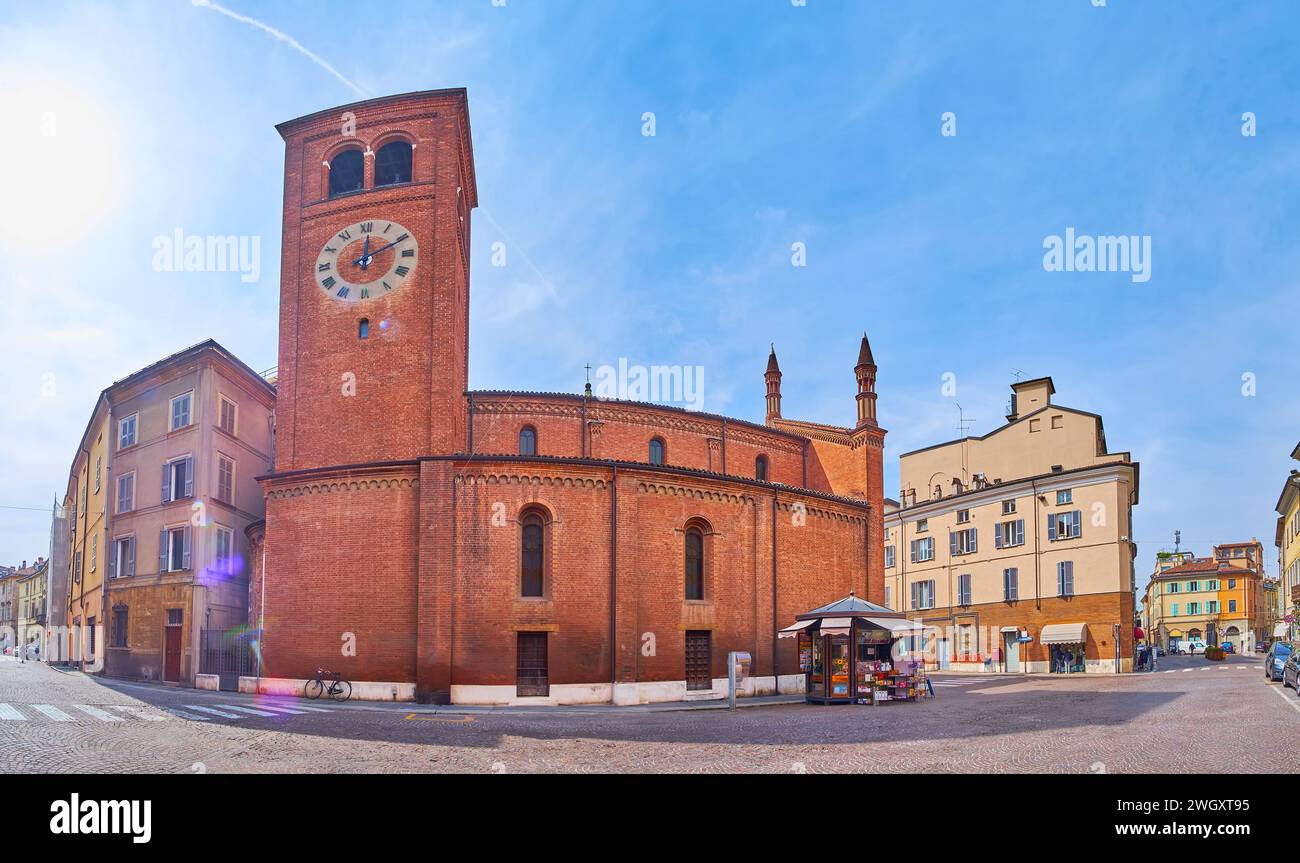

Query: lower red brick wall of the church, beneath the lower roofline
left=254, top=459, right=870, bottom=698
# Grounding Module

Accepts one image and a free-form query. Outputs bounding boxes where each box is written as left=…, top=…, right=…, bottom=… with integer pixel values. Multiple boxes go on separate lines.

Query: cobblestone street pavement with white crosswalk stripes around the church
left=0, top=656, right=1300, bottom=773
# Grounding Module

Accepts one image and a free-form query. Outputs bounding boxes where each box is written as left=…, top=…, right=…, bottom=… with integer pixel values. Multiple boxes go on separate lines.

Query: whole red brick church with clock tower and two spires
left=248, top=90, right=885, bottom=704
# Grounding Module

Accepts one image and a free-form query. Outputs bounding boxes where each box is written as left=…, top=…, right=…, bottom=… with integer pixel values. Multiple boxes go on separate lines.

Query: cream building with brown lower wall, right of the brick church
left=885, top=377, right=1139, bottom=673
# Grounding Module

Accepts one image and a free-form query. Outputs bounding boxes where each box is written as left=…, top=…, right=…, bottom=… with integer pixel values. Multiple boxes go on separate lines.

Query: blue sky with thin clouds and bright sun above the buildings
left=0, top=0, right=1300, bottom=592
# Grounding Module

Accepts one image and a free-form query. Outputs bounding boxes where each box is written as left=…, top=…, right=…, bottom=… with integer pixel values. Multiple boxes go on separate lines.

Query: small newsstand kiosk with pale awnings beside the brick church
left=777, top=593, right=927, bottom=704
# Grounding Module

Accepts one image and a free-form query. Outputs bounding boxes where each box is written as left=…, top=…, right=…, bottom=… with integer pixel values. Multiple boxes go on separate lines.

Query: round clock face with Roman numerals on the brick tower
left=316, top=218, right=420, bottom=303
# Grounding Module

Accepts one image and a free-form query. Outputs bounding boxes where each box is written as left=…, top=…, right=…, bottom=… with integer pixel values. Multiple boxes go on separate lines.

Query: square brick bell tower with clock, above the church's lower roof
left=276, top=88, right=478, bottom=472
